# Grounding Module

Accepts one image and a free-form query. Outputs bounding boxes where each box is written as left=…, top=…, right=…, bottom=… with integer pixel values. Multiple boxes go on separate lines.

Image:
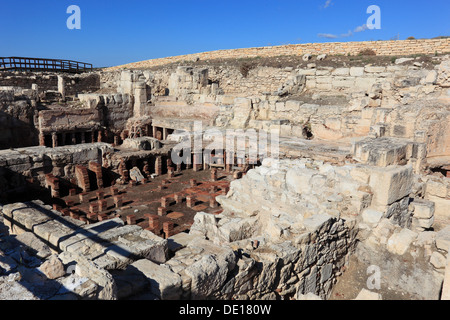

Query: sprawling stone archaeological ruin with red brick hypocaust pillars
left=0, top=38, right=450, bottom=300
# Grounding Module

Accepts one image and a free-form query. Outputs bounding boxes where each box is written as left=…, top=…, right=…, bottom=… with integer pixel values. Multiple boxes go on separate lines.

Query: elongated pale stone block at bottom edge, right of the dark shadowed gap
left=128, top=259, right=181, bottom=300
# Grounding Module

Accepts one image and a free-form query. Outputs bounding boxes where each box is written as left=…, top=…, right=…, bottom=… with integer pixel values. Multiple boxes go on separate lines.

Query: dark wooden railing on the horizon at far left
left=0, top=57, right=93, bottom=73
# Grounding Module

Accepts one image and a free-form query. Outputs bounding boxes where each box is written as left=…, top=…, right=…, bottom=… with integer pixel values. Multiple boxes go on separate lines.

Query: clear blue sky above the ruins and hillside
left=0, top=0, right=450, bottom=67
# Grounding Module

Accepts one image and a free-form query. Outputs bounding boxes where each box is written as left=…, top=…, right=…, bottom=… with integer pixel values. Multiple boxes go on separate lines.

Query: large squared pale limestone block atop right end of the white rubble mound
left=369, top=165, right=413, bottom=206
